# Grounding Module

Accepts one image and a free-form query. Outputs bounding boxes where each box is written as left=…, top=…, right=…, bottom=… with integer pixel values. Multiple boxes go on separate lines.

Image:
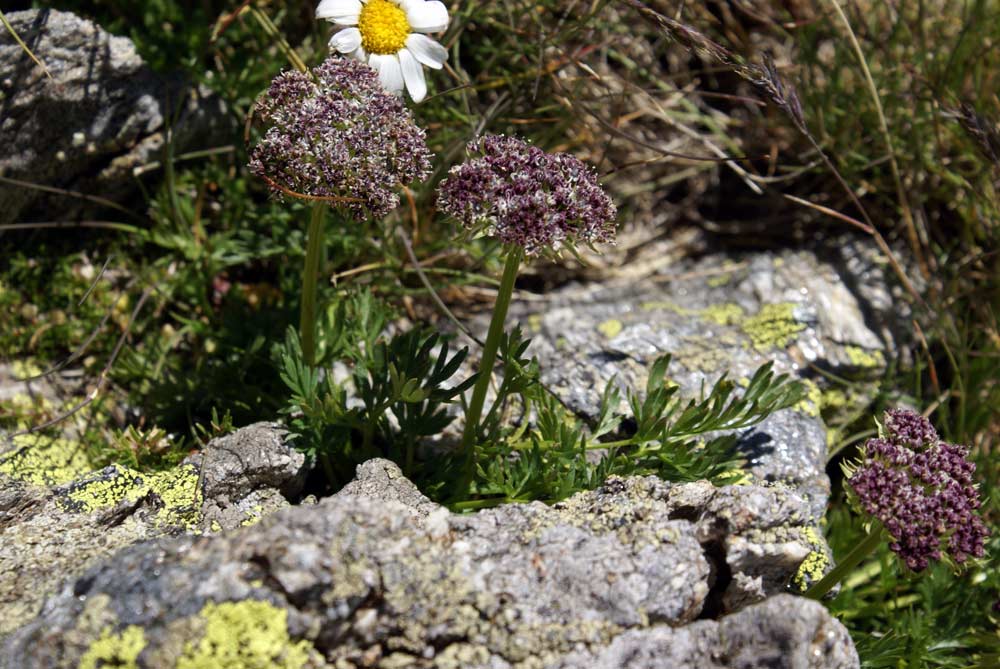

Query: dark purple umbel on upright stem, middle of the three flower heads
left=438, top=135, right=616, bottom=255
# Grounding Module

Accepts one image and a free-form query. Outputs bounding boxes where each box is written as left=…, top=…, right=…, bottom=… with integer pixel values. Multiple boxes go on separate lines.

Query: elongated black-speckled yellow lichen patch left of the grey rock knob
left=62, top=465, right=202, bottom=531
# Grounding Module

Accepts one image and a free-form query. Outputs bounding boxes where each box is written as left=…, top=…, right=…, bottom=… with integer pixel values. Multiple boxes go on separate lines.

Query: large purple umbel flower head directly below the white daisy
left=250, top=56, right=431, bottom=219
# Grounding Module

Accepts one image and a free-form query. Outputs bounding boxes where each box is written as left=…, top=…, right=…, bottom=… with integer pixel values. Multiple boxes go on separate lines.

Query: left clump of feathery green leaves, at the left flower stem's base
left=277, top=293, right=472, bottom=484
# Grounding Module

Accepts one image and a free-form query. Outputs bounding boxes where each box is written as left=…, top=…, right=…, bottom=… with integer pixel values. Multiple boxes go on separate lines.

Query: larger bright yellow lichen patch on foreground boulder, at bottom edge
left=176, top=600, right=312, bottom=669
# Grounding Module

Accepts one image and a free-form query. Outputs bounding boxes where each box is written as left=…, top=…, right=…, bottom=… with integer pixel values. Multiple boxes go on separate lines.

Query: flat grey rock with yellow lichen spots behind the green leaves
left=478, top=244, right=893, bottom=522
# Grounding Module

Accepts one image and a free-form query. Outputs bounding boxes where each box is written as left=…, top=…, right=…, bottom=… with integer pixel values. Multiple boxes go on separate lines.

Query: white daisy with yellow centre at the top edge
left=316, top=0, right=448, bottom=102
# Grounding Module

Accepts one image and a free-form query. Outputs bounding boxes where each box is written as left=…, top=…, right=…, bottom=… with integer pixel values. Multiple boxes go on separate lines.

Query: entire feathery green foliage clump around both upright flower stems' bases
left=276, top=293, right=804, bottom=509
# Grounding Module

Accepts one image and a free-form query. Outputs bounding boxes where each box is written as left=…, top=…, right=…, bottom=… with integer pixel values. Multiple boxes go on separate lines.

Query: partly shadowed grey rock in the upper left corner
left=0, top=9, right=225, bottom=223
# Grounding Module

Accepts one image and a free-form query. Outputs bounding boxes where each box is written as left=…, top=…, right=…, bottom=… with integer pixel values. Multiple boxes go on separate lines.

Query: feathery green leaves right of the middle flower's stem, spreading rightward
left=456, top=344, right=804, bottom=508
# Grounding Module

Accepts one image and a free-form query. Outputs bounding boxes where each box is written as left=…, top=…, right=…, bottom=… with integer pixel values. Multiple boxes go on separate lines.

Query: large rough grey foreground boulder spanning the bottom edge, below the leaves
left=0, top=470, right=858, bottom=669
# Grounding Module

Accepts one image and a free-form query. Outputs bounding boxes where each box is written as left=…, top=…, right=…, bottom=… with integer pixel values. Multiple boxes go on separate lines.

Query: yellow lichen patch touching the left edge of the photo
left=0, top=434, right=93, bottom=486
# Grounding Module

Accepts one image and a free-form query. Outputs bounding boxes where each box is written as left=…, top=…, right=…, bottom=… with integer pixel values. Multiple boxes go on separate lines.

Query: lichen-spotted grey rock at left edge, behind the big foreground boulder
left=0, top=423, right=305, bottom=636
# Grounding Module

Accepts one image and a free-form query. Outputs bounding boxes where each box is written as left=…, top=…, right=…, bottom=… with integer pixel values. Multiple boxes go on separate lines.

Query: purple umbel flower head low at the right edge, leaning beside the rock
left=848, top=409, right=989, bottom=571
